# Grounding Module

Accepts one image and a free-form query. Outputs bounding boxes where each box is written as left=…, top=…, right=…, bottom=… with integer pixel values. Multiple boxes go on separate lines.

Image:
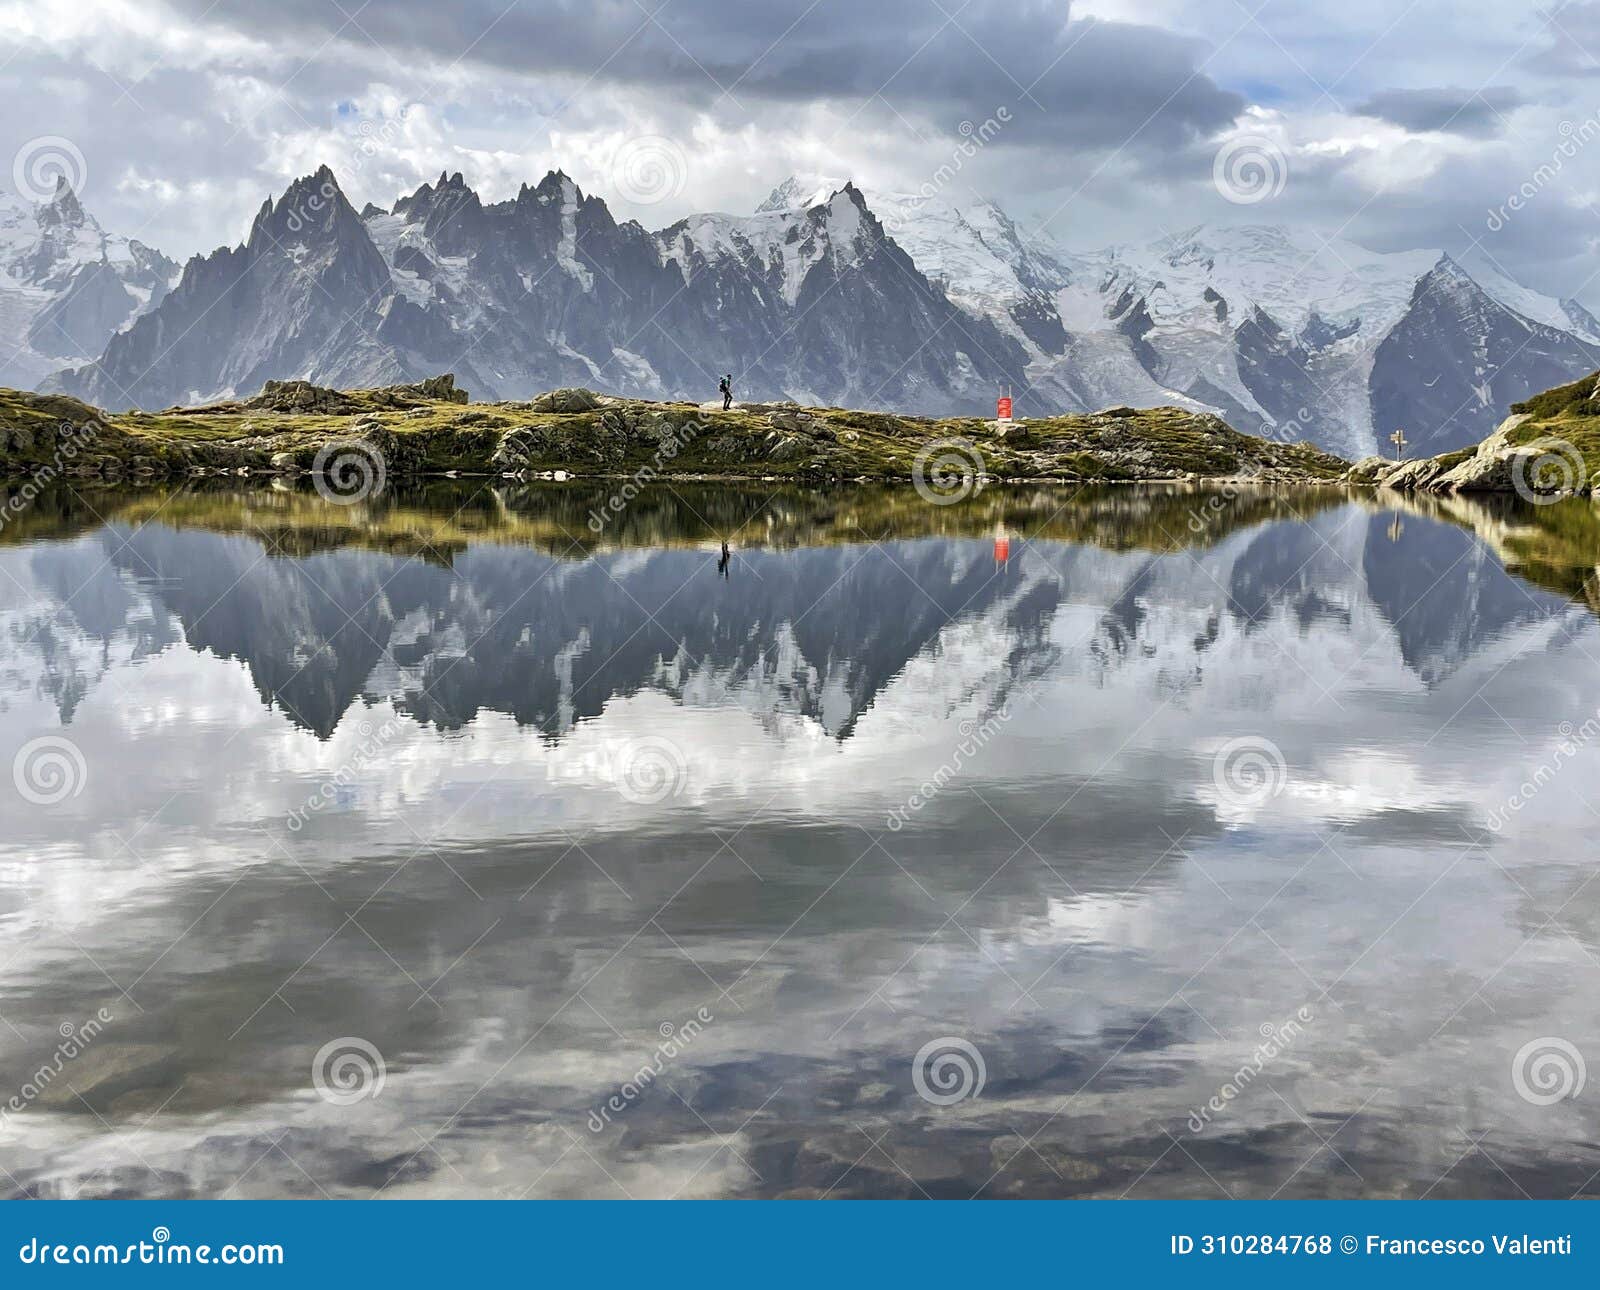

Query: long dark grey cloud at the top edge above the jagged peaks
left=156, top=0, right=1245, bottom=147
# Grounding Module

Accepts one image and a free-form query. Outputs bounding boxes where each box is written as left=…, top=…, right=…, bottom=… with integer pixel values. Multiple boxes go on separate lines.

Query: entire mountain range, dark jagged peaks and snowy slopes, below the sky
left=12, top=166, right=1600, bottom=458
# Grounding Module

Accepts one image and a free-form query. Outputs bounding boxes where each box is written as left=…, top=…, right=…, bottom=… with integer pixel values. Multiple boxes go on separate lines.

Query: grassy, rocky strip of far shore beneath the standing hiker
left=0, top=384, right=1347, bottom=483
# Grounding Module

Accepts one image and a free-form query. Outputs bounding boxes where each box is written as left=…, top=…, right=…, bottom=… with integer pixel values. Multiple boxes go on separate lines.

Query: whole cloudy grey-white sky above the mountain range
left=9, top=0, right=1600, bottom=304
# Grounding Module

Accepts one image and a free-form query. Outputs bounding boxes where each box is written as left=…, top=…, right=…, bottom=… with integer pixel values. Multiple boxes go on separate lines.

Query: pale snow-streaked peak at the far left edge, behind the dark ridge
left=0, top=179, right=178, bottom=386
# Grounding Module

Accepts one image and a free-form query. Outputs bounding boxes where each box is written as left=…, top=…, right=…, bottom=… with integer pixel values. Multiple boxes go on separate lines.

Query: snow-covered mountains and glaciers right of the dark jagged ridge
left=748, top=176, right=1600, bottom=456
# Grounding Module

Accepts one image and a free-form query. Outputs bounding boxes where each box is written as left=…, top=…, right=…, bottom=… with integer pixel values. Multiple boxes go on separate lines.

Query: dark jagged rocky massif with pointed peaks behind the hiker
left=56, top=170, right=1022, bottom=411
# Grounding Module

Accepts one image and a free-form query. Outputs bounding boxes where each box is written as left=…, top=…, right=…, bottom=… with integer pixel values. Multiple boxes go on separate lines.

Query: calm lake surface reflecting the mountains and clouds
left=0, top=488, right=1600, bottom=1197
